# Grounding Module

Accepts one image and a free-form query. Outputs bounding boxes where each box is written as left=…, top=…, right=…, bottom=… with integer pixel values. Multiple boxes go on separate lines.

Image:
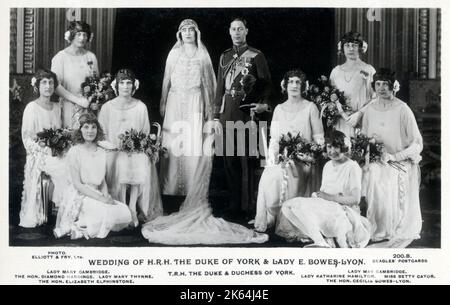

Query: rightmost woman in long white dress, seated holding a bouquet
left=362, top=69, right=423, bottom=247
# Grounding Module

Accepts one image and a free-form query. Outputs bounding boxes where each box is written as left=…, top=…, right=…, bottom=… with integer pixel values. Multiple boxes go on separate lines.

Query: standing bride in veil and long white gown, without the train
left=160, top=19, right=216, bottom=196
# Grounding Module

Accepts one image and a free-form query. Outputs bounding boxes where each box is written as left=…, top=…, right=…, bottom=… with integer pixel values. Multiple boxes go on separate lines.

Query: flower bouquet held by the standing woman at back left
left=81, top=72, right=116, bottom=112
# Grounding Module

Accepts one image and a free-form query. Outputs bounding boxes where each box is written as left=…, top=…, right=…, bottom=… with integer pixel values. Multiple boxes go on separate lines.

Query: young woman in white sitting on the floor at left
left=54, top=113, right=131, bottom=239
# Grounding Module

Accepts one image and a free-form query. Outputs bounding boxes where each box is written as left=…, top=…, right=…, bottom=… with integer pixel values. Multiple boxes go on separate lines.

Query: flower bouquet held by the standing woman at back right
left=306, top=75, right=352, bottom=127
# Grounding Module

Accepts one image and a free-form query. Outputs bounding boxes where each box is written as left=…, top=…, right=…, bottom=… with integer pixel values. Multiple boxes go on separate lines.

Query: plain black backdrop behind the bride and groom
left=111, top=8, right=336, bottom=120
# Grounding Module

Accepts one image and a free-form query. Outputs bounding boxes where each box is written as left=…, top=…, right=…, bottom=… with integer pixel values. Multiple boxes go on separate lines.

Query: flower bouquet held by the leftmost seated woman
left=36, top=128, right=73, bottom=157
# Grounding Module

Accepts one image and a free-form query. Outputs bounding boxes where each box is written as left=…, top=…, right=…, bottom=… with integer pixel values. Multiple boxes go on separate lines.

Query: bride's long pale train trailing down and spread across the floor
left=142, top=134, right=269, bottom=245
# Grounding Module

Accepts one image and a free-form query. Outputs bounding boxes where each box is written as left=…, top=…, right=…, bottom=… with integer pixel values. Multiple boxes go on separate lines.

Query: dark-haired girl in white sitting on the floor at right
left=276, top=130, right=372, bottom=248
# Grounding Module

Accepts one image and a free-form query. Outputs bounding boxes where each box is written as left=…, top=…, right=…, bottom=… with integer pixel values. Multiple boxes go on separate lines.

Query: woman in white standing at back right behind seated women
left=330, top=31, right=375, bottom=137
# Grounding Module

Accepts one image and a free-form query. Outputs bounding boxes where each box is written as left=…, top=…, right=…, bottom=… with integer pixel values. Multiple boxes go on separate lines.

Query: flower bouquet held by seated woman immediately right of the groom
left=278, top=132, right=324, bottom=165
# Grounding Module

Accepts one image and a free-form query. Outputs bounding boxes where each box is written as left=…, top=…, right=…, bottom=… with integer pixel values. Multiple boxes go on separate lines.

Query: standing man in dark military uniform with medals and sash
left=215, top=18, right=271, bottom=215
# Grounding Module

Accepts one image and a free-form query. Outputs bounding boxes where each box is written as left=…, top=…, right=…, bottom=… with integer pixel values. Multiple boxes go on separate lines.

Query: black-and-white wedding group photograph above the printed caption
left=4, top=3, right=445, bottom=284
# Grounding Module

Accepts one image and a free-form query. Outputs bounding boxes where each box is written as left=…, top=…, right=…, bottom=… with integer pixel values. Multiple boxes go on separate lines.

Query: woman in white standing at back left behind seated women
left=51, top=21, right=98, bottom=128
